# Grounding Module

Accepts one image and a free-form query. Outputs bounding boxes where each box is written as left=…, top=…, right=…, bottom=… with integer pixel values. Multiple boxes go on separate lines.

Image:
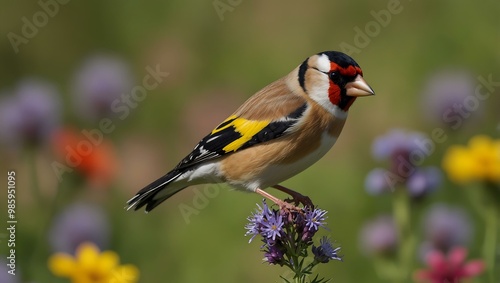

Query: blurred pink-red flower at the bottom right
left=413, top=247, right=485, bottom=283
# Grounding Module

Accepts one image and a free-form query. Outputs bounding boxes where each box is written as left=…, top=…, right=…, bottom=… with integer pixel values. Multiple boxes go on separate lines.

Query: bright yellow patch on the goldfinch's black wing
left=212, top=115, right=271, bottom=152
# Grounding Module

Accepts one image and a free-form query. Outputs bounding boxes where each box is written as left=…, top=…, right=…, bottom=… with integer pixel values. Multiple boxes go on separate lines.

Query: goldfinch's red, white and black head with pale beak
left=298, top=51, right=375, bottom=114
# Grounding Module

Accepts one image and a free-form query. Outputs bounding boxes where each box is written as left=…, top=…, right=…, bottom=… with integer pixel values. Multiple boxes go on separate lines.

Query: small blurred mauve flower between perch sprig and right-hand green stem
left=360, top=215, right=398, bottom=255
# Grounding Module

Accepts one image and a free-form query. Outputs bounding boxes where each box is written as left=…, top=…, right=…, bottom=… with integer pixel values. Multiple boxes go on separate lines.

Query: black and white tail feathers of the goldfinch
left=125, top=170, right=186, bottom=212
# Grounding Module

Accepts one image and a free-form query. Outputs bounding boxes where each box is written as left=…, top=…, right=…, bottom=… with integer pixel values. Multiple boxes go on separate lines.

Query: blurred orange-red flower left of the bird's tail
left=53, top=129, right=118, bottom=188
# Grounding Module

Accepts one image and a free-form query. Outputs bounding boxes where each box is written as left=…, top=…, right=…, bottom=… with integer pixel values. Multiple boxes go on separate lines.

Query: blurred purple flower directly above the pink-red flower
left=422, top=204, right=473, bottom=253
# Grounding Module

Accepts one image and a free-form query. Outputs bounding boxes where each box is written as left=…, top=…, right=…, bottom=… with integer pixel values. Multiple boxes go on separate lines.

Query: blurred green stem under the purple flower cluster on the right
left=393, top=188, right=415, bottom=282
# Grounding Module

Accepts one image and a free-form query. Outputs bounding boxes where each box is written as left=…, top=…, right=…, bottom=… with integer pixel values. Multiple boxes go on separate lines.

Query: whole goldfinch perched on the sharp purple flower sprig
left=126, top=51, right=375, bottom=213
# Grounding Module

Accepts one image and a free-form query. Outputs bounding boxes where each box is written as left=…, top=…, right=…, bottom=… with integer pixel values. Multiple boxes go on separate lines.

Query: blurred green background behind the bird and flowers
left=0, top=0, right=500, bottom=283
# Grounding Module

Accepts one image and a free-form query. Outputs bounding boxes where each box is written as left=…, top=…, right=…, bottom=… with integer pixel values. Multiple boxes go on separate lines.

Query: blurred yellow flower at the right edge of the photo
left=443, top=136, right=500, bottom=183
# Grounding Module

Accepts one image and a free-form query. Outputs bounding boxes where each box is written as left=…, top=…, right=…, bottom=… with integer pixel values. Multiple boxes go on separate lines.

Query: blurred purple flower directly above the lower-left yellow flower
left=49, top=203, right=110, bottom=254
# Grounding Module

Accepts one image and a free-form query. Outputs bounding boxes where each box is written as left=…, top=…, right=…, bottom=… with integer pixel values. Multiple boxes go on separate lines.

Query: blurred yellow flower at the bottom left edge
left=49, top=243, right=139, bottom=283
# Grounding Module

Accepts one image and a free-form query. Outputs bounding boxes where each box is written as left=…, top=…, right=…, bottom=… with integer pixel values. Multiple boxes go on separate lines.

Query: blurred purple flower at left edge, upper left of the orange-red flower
left=0, top=79, right=61, bottom=148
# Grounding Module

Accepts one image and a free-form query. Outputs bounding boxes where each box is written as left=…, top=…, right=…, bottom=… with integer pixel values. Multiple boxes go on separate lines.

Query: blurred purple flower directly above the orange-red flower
left=73, top=55, right=134, bottom=119
